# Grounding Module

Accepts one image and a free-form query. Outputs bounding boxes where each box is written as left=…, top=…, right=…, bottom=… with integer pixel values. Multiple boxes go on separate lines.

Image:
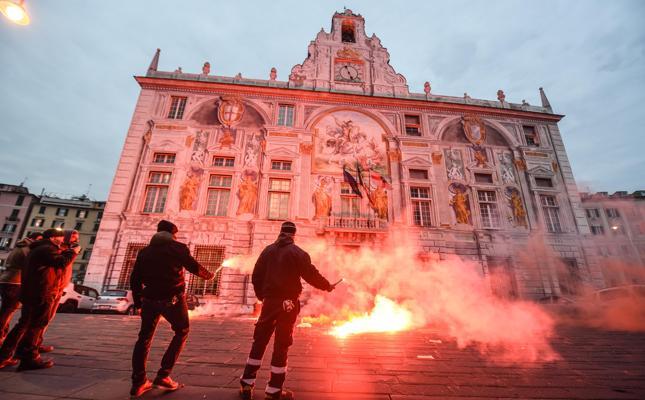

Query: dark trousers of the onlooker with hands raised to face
left=0, top=295, right=58, bottom=361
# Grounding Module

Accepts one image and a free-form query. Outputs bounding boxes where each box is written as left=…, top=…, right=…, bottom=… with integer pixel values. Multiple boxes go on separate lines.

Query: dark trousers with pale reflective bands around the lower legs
left=242, top=299, right=300, bottom=393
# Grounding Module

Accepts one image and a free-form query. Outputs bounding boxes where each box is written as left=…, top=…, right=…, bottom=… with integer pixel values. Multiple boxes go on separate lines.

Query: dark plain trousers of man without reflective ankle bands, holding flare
left=132, top=295, right=189, bottom=384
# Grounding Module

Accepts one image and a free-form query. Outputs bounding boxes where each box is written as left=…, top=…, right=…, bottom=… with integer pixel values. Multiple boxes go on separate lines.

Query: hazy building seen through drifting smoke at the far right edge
left=581, top=190, right=645, bottom=286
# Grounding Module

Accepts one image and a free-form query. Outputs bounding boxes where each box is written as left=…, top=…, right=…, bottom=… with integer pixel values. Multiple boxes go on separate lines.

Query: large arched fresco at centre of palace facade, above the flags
left=314, top=111, right=389, bottom=176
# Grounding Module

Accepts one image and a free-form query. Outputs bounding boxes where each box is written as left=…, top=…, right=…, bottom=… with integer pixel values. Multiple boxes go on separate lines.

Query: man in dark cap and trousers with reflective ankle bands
left=240, top=222, right=334, bottom=400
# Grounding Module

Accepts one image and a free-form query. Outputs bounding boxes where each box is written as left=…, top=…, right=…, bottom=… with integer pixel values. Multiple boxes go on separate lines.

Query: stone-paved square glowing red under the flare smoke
left=0, top=314, right=645, bottom=400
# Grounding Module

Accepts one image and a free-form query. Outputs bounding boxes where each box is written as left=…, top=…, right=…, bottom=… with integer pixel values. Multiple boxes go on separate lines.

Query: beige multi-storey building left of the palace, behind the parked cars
left=24, top=195, right=105, bottom=283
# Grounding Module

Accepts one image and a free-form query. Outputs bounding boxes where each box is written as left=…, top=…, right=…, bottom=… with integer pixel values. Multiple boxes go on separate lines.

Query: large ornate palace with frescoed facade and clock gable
left=85, top=10, right=604, bottom=306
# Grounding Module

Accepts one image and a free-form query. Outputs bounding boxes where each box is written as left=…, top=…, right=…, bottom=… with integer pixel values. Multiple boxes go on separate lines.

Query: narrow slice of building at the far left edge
left=0, top=183, right=36, bottom=268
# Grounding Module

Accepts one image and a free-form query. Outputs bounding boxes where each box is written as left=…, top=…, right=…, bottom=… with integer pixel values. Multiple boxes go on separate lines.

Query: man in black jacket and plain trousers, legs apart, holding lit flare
left=130, top=220, right=215, bottom=397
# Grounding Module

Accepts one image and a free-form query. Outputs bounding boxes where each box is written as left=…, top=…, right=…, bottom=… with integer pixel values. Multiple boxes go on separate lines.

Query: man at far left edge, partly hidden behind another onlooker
left=0, top=232, right=43, bottom=343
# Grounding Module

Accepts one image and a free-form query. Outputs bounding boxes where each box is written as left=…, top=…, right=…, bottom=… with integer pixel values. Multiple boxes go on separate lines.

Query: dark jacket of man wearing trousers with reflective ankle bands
left=252, top=234, right=332, bottom=300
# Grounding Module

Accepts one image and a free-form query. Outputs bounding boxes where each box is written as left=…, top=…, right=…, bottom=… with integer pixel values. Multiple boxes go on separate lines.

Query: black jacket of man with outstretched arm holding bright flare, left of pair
left=130, top=232, right=213, bottom=305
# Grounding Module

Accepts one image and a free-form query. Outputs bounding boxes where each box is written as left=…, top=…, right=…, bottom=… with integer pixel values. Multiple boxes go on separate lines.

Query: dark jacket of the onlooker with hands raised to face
left=20, top=239, right=76, bottom=303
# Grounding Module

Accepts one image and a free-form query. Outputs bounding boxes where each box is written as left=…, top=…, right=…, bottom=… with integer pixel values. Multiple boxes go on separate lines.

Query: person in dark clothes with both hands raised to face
left=0, top=229, right=81, bottom=371
